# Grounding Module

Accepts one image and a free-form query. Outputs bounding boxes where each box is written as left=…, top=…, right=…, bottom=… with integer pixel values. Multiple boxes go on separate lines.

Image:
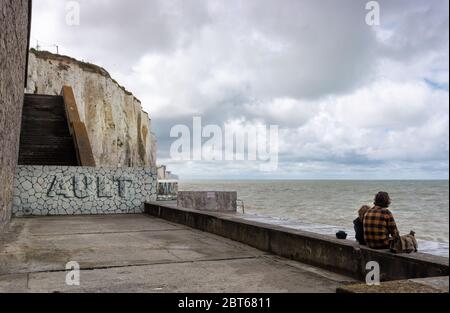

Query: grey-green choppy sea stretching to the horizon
left=179, top=180, right=449, bottom=257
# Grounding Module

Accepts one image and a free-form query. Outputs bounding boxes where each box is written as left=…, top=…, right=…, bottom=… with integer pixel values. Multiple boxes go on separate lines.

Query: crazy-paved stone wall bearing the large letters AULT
left=13, top=166, right=156, bottom=217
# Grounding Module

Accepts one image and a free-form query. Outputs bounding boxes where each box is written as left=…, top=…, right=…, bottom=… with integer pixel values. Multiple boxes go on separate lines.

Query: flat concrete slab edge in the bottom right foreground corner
left=337, top=276, right=449, bottom=293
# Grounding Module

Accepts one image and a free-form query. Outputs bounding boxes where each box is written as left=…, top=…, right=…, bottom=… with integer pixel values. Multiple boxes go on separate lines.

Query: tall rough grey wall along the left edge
left=0, top=0, right=28, bottom=232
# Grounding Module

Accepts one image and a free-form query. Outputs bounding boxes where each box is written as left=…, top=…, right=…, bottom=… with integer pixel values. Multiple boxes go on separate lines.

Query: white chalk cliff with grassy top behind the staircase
left=26, top=50, right=156, bottom=167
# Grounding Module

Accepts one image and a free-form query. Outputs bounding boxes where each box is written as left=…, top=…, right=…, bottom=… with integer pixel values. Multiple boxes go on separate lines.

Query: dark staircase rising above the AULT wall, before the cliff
left=19, top=94, right=79, bottom=166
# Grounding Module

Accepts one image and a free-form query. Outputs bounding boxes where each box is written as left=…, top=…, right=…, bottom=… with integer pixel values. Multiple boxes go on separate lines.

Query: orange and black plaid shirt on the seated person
left=364, top=206, right=398, bottom=249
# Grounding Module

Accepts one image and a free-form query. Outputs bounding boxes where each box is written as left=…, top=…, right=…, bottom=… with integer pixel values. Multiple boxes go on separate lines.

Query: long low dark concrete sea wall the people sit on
left=145, top=203, right=449, bottom=281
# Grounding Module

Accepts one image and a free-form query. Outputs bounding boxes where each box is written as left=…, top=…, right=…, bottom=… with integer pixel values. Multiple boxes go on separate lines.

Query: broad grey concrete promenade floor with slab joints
left=0, top=215, right=355, bottom=292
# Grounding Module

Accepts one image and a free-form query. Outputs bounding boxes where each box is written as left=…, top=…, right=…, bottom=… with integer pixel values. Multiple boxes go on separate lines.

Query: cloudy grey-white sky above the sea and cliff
left=31, top=0, right=449, bottom=179
